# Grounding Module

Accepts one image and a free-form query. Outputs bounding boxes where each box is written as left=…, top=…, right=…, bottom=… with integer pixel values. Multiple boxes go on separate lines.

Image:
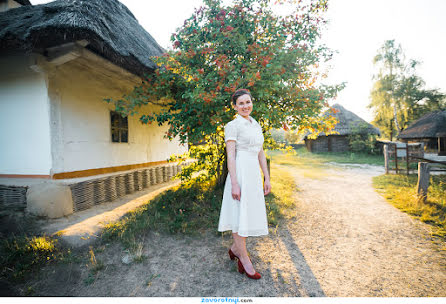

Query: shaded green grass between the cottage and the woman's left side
left=102, top=182, right=223, bottom=249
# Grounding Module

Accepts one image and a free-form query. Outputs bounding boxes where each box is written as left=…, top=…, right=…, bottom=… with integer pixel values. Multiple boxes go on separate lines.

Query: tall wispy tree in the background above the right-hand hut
left=369, top=40, right=445, bottom=140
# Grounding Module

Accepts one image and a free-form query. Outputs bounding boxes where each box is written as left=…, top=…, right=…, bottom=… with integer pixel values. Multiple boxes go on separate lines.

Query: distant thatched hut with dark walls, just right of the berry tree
left=304, top=104, right=380, bottom=152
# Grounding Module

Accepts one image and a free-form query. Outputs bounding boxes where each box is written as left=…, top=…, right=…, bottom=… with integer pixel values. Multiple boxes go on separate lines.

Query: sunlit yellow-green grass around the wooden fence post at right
left=373, top=174, right=446, bottom=239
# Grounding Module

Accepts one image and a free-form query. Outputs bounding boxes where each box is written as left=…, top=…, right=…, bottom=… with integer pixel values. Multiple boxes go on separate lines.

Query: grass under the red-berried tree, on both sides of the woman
left=102, top=166, right=295, bottom=247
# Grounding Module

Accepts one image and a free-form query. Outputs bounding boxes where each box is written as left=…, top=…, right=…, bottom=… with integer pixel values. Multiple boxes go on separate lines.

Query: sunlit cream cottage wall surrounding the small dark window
left=49, top=58, right=187, bottom=173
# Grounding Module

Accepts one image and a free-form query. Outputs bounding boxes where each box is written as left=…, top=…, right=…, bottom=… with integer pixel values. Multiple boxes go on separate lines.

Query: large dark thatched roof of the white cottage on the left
left=0, top=0, right=164, bottom=75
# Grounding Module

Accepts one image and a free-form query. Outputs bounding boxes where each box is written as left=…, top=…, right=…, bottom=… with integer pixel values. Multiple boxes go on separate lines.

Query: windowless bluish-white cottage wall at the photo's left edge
left=0, top=56, right=51, bottom=175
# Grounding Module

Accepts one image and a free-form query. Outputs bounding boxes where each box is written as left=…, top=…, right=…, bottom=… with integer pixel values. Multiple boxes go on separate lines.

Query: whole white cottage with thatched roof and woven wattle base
left=0, top=0, right=187, bottom=217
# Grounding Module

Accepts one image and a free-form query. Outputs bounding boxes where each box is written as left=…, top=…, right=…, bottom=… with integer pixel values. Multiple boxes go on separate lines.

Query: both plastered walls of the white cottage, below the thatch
left=0, top=55, right=187, bottom=177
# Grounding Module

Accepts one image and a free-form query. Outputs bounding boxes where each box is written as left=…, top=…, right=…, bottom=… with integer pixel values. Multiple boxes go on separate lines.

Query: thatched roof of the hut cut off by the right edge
left=398, top=110, right=446, bottom=139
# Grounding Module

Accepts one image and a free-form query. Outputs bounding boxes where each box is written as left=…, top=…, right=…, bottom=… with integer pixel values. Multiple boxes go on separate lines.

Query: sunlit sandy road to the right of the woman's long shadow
left=288, top=166, right=446, bottom=297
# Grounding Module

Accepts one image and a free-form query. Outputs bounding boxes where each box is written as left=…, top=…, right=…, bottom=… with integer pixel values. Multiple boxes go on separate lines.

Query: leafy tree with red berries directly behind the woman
left=108, top=0, right=341, bottom=180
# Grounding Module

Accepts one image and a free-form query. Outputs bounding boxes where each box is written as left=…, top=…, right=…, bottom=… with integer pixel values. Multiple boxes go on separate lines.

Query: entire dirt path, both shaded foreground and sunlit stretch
left=24, top=166, right=446, bottom=297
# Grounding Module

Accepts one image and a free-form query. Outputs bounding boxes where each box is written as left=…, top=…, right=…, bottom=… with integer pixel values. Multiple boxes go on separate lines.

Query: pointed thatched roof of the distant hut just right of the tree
left=304, top=104, right=381, bottom=138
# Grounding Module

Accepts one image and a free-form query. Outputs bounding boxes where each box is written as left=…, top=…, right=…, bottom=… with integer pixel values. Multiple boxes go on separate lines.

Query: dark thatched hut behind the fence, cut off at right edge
left=398, top=110, right=446, bottom=155
